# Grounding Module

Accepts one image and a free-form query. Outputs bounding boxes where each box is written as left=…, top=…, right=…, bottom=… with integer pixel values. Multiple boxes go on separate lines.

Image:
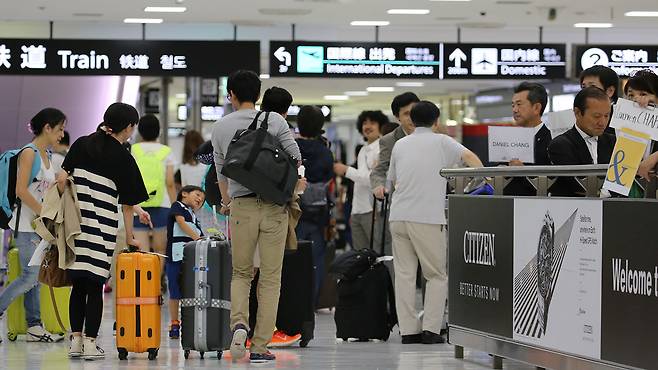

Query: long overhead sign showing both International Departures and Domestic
left=270, top=41, right=566, bottom=79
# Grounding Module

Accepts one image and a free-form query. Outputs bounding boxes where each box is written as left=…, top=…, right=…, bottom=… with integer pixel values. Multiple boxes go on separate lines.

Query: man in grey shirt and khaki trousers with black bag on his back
left=212, top=70, right=301, bottom=362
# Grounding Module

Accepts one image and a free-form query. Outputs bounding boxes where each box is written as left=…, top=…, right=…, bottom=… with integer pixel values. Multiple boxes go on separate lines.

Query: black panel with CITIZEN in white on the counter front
left=448, top=196, right=514, bottom=338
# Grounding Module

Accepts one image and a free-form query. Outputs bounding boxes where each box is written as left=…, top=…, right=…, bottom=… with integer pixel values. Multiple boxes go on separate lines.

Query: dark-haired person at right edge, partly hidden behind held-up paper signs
left=624, top=70, right=658, bottom=180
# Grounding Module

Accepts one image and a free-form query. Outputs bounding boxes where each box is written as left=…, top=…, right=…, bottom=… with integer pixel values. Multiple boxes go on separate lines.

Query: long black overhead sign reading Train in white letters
left=0, top=39, right=260, bottom=76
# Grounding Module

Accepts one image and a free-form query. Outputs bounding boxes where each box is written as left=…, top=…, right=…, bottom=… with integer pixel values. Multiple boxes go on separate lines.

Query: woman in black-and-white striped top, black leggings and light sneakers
left=58, top=103, right=148, bottom=360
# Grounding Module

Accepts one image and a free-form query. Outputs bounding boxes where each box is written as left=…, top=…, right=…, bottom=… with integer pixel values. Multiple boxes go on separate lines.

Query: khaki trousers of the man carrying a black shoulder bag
left=230, top=198, right=288, bottom=353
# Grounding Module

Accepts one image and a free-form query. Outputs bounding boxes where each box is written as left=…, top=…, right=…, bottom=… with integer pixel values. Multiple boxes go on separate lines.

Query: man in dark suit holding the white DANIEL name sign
left=503, top=82, right=551, bottom=196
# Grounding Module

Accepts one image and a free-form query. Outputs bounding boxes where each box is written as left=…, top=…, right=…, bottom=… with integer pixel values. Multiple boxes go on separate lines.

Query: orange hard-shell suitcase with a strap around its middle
left=114, top=252, right=162, bottom=360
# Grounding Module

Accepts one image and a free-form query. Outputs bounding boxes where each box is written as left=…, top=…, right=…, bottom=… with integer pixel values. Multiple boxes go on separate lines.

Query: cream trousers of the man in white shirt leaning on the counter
left=391, top=221, right=448, bottom=335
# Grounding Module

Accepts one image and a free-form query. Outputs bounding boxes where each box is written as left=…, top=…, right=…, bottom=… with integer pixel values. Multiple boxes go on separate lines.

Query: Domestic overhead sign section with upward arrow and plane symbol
left=441, top=44, right=566, bottom=80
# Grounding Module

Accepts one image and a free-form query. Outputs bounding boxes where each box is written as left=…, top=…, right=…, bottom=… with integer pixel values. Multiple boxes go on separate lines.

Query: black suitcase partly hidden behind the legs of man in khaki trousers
left=249, top=241, right=315, bottom=347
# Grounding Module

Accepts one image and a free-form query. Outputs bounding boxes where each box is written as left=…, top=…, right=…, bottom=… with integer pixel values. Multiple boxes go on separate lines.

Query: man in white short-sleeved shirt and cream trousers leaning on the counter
left=388, top=101, right=482, bottom=344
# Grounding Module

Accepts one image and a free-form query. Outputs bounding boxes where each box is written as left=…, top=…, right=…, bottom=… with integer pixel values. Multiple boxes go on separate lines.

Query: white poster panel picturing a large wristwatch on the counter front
left=513, top=199, right=603, bottom=359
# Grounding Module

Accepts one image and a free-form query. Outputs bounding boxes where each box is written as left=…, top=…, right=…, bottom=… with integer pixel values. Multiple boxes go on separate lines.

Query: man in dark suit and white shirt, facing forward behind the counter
left=548, top=87, right=616, bottom=197
